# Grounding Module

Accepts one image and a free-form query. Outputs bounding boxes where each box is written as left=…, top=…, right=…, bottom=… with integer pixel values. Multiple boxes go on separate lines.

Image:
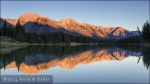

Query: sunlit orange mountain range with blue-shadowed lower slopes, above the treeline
left=0, top=13, right=139, bottom=39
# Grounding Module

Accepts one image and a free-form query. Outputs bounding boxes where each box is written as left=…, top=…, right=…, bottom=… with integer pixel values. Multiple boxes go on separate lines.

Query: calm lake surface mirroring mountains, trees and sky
left=0, top=45, right=150, bottom=83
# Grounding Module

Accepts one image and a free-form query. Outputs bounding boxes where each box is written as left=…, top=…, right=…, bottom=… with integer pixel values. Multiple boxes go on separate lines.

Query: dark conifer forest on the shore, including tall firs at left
left=0, top=20, right=99, bottom=43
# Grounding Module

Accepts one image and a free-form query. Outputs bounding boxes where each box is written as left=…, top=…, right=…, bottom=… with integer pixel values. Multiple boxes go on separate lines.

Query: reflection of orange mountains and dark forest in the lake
left=0, top=46, right=141, bottom=74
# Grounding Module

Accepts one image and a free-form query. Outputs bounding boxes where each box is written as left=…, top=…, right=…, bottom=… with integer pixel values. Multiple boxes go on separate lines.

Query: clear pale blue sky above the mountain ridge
left=1, top=1, right=149, bottom=30
